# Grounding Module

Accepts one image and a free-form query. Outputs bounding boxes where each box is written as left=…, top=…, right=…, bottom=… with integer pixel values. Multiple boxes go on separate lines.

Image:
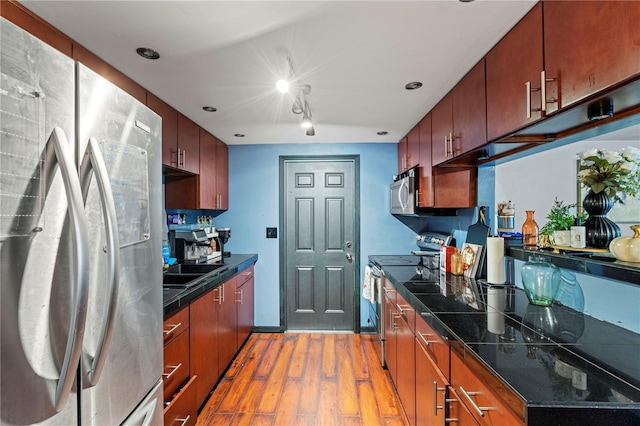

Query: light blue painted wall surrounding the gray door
left=214, top=143, right=416, bottom=327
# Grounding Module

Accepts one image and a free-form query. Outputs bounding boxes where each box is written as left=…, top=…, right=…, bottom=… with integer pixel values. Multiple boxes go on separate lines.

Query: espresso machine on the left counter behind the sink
left=169, top=229, right=222, bottom=263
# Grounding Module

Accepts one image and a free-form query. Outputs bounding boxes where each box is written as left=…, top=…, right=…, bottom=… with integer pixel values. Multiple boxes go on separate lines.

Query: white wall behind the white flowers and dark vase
left=493, top=136, right=640, bottom=235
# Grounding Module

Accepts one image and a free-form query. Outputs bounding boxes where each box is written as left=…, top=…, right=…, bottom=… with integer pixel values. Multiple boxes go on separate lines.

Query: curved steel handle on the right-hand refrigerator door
left=80, top=138, right=120, bottom=386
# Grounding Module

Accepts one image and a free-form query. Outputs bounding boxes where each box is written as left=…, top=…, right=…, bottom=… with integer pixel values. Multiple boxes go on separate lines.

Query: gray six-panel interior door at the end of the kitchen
left=280, top=157, right=359, bottom=330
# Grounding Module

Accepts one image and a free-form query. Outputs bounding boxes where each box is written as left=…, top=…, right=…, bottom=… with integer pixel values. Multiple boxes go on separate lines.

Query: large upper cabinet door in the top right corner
left=543, top=1, right=640, bottom=111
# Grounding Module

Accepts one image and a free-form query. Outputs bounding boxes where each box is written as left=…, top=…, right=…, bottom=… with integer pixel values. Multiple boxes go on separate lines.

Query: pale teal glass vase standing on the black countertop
left=522, top=256, right=561, bottom=306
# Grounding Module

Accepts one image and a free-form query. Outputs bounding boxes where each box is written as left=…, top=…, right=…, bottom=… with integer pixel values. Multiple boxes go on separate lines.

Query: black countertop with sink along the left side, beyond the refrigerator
left=162, top=254, right=258, bottom=316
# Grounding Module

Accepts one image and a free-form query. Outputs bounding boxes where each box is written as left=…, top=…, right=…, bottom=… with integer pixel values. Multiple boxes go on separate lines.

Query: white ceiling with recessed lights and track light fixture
left=22, top=0, right=535, bottom=144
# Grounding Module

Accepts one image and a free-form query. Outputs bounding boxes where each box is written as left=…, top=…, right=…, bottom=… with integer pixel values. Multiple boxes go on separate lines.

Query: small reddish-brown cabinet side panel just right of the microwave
left=433, top=167, right=477, bottom=207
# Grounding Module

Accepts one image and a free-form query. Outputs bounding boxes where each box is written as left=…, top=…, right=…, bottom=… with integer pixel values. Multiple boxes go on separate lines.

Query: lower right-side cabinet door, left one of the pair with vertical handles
left=415, top=337, right=453, bottom=425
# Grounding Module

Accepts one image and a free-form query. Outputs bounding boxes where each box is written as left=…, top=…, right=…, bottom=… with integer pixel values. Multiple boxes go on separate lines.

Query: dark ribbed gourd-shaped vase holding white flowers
left=582, top=190, right=620, bottom=248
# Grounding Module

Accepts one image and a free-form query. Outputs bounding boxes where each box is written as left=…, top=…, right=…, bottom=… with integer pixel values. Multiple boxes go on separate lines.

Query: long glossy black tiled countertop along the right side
left=372, top=256, right=640, bottom=424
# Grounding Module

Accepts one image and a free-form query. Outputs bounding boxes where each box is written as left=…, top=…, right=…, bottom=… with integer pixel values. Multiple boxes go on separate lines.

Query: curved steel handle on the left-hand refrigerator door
left=47, top=127, right=89, bottom=412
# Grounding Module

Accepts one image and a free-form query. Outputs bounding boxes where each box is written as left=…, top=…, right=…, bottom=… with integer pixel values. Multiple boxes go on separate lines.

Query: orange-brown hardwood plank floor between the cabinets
left=197, top=333, right=407, bottom=426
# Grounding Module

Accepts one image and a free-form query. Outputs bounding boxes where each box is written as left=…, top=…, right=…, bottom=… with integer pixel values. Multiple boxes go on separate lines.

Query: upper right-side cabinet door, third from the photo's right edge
left=452, top=59, right=487, bottom=156
